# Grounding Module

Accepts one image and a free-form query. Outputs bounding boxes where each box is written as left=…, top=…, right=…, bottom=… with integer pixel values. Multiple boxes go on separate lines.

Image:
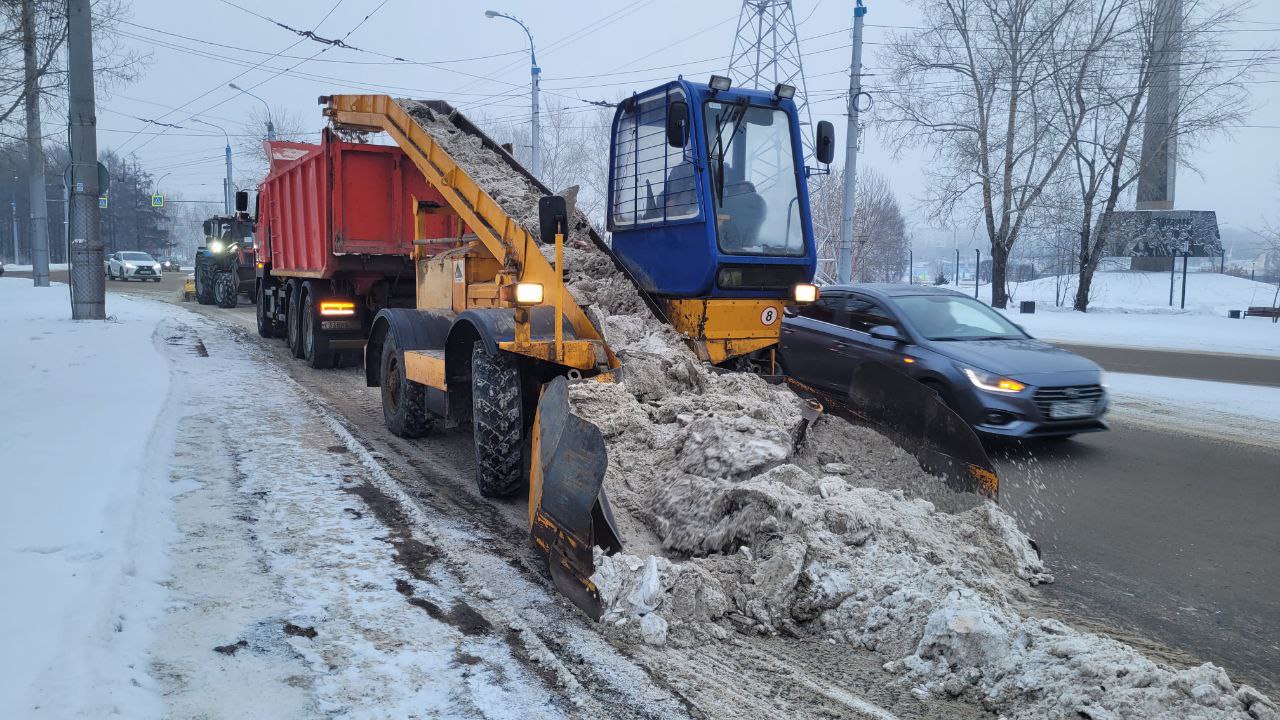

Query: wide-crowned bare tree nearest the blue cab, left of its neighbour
left=882, top=0, right=1108, bottom=307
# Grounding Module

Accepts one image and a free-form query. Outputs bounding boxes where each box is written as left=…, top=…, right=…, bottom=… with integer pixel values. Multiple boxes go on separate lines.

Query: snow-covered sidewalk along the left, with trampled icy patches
left=0, top=279, right=570, bottom=719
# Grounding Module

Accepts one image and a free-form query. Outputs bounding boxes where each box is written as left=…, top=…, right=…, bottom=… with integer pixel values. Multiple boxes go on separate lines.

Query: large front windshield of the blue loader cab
left=707, top=101, right=804, bottom=256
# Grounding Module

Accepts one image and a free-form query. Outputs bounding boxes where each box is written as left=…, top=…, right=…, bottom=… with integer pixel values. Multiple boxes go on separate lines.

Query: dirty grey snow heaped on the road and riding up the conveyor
left=402, top=101, right=1272, bottom=719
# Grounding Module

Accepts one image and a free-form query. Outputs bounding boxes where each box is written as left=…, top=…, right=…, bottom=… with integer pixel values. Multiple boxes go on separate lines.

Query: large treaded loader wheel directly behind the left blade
left=471, top=343, right=525, bottom=497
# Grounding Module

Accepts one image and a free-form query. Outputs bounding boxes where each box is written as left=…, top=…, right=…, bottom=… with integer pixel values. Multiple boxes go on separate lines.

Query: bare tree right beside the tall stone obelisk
left=1057, top=0, right=1265, bottom=313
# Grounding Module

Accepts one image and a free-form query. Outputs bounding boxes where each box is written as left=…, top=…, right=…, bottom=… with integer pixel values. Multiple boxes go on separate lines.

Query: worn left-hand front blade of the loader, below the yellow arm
left=529, top=378, right=622, bottom=620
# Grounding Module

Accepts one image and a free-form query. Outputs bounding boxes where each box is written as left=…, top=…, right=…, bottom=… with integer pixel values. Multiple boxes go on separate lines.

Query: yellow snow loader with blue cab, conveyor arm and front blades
left=293, top=77, right=995, bottom=618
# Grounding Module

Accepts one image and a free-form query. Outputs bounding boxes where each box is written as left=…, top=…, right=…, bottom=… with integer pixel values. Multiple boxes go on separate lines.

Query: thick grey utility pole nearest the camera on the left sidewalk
left=67, top=0, right=106, bottom=320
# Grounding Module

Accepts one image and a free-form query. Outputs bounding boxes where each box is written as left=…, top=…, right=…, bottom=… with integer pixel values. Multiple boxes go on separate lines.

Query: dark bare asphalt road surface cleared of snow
left=14, top=273, right=1280, bottom=697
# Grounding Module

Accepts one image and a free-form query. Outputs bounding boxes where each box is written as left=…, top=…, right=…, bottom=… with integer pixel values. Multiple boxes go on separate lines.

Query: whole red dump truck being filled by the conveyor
left=255, top=129, right=465, bottom=368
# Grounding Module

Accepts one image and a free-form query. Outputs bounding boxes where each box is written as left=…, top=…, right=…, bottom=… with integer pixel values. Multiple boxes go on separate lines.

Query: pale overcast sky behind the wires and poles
left=99, top=0, right=1280, bottom=243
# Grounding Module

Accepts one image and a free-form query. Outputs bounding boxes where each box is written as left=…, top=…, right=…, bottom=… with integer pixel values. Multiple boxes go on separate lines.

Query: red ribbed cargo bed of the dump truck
left=257, top=131, right=457, bottom=279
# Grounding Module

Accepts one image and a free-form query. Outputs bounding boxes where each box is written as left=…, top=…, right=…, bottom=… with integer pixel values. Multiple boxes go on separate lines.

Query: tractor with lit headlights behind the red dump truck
left=195, top=211, right=255, bottom=307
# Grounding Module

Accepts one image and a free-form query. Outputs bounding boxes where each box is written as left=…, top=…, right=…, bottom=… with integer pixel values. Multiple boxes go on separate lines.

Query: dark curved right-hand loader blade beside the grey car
left=785, top=363, right=1000, bottom=501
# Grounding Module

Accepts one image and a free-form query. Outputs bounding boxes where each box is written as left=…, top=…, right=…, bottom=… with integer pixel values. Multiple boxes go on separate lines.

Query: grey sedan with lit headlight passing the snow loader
left=780, top=284, right=1108, bottom=438
